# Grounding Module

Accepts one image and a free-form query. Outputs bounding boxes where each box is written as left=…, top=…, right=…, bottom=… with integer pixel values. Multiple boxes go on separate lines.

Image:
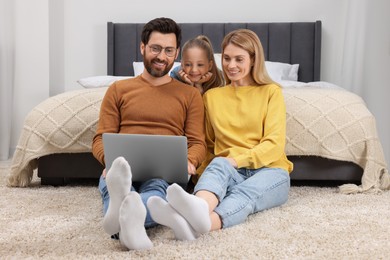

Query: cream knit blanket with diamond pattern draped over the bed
left=8, top=84, right=390, bottom=193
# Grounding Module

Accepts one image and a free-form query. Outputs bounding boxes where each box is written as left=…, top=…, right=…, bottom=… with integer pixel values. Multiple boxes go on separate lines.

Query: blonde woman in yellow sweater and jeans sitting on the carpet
left=148, top=29, right=293, bottom=239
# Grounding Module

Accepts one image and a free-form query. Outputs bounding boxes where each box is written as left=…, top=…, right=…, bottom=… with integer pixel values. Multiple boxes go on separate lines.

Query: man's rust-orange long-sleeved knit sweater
left=92, top=76, right=206, bottom=167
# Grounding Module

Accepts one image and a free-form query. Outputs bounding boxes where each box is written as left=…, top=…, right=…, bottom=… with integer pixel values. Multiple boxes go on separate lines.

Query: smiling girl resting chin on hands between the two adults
left=171, top=35, right=224, bottom=94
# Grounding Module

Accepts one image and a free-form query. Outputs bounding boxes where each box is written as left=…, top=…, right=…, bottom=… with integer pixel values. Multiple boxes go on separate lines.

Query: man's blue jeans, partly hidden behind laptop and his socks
left=99, top=176, right=169, bottom=228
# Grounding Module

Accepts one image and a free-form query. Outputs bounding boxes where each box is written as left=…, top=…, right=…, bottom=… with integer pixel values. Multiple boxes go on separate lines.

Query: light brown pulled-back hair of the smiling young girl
left=182, top=35, right=225, bottom=93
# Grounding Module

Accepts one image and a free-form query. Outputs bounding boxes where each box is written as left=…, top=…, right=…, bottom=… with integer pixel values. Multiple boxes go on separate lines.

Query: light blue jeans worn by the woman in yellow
left=194, top=157, right=290, bottom=228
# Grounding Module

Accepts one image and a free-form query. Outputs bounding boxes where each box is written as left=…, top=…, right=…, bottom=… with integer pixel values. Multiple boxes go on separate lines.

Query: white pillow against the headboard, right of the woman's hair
left=265, top=61, right=299, bottom=82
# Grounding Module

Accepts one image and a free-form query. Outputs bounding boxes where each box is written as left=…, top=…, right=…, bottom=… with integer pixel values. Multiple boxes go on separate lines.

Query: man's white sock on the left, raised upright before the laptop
left=103, top=157, right=131, bottom=235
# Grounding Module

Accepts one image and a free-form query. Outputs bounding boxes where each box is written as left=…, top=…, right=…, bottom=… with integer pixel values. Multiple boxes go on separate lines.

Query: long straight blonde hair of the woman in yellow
left=222, top=29, right=277, bottom=85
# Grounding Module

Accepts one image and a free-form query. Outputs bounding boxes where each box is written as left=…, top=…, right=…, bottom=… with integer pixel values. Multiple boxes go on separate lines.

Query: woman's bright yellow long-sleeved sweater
left=201, top=84, right=293, bottom=172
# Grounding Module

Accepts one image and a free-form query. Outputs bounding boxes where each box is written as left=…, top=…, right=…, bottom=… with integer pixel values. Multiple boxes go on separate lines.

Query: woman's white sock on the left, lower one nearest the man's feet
left=147, top=196, right=198, bottom=240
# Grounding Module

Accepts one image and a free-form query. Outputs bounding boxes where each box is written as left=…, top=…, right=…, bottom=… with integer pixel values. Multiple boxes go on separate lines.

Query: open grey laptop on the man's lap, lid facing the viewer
left=103, top=133, right=189, bottom=187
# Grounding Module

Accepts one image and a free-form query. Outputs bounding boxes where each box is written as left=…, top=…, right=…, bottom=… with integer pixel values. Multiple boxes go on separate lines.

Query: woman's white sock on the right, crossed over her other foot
left=167, top=183, right=211, bottom=234
